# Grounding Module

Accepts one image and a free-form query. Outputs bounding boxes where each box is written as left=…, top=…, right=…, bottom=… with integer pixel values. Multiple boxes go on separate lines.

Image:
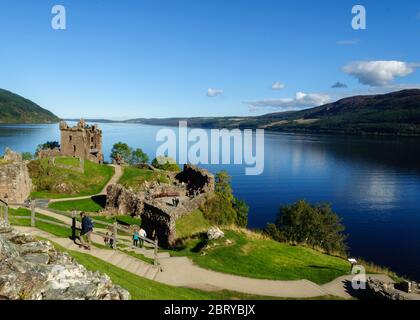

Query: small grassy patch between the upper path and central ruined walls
left=118, top=167, right=169, bottom=191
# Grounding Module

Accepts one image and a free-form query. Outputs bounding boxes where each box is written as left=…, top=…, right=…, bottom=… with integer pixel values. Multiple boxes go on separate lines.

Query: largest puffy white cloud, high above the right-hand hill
left=343, top=61, right=418, bottom=87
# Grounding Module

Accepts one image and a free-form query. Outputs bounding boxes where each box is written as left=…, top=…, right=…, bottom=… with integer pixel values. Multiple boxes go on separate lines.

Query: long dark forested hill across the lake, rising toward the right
left=128, top=89, right=420, bottom=135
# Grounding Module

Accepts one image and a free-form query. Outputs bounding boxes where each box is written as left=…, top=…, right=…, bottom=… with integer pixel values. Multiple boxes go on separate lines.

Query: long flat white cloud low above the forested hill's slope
left=245, top=92, right=331, bottom=110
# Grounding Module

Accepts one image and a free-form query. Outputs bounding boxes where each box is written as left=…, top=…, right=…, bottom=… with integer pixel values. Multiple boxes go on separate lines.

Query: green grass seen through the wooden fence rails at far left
left=9, top=208, right=71, bottom=238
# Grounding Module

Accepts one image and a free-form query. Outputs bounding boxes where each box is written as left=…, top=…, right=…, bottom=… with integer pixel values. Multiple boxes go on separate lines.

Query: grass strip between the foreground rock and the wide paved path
left=46, top=240, right=337, bottom=300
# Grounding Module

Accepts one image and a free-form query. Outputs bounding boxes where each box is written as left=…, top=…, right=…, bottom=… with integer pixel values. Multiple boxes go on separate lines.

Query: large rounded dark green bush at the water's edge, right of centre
left=266, top=200, right=347, bottom=253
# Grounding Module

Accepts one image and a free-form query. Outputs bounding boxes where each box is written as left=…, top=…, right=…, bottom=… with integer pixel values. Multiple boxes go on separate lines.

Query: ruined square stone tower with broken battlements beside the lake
left=60, top=120, right=104, bottom=163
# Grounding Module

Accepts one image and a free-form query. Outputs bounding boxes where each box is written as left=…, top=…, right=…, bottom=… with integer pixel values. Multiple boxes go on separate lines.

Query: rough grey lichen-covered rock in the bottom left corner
left=0, top=221, right=130, bottom=300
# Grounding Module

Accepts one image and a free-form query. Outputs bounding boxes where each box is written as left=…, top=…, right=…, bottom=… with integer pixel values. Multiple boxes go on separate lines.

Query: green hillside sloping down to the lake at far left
left=0, top=89, right=59, bottom=123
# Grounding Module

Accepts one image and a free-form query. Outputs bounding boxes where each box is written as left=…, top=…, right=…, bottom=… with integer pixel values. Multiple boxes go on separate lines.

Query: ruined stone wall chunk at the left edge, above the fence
left=0, top=149, right=32, bottom=203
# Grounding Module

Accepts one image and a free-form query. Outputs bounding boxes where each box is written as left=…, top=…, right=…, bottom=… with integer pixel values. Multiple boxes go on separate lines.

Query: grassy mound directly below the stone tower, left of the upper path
left=28, top=159, right=114, bottom=199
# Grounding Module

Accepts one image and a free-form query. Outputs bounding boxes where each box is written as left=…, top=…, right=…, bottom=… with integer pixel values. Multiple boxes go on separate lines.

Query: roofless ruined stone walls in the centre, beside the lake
left=106, top=164, right=214, bottom=246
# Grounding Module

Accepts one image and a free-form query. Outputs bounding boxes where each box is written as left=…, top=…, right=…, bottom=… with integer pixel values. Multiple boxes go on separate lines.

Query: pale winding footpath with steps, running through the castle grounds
left=16, top=166, right=398, bottom=299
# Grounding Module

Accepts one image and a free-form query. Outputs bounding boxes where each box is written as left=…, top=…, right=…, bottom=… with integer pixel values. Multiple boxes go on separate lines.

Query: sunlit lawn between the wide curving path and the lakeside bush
left=170, top=231, right=350, bottom=284
